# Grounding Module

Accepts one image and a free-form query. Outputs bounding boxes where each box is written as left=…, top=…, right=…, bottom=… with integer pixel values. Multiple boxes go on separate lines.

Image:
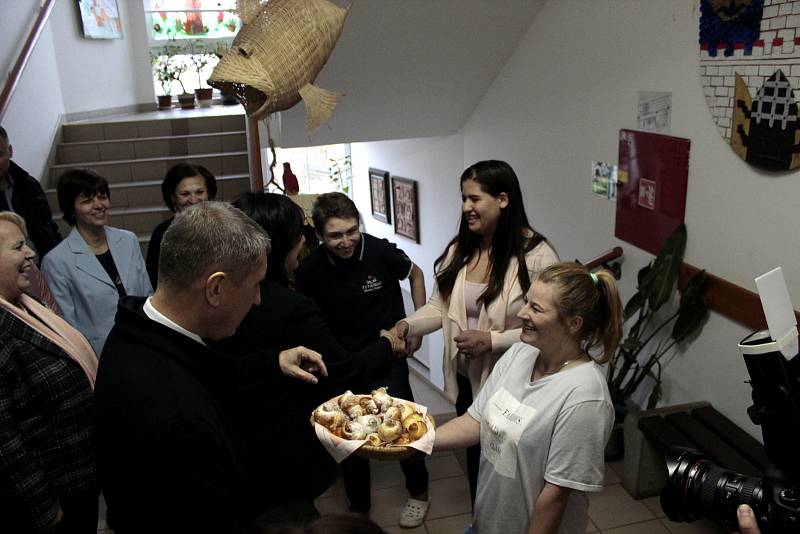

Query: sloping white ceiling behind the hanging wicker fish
left=281, top=0, right=546, bottom=146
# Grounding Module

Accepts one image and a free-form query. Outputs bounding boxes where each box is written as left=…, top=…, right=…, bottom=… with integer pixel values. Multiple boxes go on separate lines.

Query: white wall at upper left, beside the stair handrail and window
left=0, top=0, right=154, bottom=177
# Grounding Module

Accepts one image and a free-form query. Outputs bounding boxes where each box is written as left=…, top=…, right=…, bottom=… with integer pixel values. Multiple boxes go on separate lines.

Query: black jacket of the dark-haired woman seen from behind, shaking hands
left=220, top=280, right=396, bottom=501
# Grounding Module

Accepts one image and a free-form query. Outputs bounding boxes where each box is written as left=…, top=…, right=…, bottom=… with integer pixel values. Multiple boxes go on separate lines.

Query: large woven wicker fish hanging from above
left=208, top=0, right=349, bottom=131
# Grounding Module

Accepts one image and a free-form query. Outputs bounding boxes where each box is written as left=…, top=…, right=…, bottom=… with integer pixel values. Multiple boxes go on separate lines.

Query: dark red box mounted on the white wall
left=614, top=130, right=690, bottom=254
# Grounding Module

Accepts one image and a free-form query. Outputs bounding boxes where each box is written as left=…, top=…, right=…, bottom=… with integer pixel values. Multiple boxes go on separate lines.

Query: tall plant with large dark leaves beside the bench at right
left=606, top=224, right=708, bottom=460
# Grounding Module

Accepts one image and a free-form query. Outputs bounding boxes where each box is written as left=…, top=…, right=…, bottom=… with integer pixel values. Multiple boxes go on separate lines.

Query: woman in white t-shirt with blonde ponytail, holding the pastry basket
left=434, top=263, right=622, bottom=534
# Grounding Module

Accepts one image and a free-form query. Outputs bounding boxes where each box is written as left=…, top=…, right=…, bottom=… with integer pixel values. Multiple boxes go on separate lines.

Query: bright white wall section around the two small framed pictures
left=351, top=135, right=464, bottom=387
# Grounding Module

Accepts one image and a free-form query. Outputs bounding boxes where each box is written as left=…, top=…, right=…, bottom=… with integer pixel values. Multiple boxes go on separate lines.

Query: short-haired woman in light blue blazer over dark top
left=42, top=169, right=153, bottom=357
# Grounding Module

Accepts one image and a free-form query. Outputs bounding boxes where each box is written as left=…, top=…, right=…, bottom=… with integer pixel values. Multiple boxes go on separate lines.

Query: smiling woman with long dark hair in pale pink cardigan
left=395, top=160, right=559, bottom=502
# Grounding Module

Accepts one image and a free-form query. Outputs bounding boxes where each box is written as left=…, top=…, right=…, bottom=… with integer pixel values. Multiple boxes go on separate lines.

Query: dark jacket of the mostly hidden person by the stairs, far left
left=8, top=161, right=61, bottom=261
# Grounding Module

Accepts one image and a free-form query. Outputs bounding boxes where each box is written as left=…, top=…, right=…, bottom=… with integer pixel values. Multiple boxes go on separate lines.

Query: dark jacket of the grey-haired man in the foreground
left=95, top=297, right=280, bottom=534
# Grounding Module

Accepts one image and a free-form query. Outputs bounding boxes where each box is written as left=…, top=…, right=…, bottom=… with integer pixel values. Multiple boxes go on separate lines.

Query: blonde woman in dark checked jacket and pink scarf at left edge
left=0, top=211, right=99, bottom=534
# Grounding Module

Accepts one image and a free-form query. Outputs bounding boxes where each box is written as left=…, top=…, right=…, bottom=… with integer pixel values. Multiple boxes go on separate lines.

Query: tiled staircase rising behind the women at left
left=43, top=111, right=250, bottom=255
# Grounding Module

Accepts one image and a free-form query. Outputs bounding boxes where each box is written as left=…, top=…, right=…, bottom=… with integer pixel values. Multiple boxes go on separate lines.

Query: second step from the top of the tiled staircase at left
left=56, top=130, right=247, bottom=166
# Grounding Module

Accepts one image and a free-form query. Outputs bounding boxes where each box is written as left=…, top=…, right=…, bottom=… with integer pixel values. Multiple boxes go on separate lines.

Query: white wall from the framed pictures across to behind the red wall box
left=353, top=0, right=800, bottom=437
